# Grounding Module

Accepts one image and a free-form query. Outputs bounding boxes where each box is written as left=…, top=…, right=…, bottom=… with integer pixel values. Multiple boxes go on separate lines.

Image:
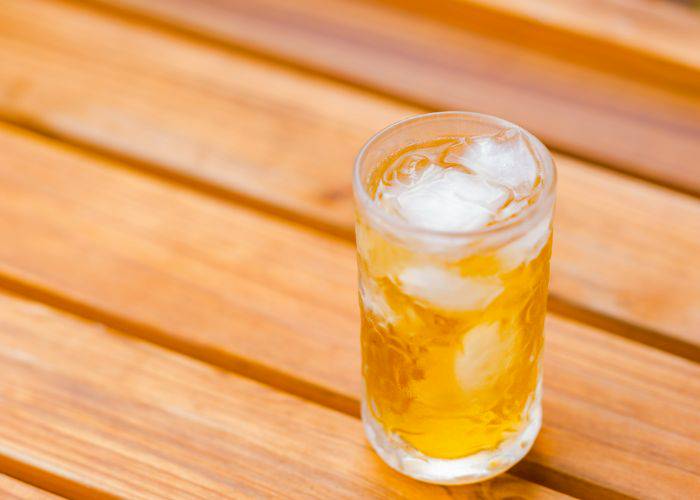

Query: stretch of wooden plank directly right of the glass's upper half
left=551, top=161, right=700, bottom=354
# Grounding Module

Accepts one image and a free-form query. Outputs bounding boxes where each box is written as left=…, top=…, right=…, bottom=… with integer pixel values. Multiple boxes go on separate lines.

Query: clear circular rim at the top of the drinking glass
left=352, top=111, right=557, bottom=238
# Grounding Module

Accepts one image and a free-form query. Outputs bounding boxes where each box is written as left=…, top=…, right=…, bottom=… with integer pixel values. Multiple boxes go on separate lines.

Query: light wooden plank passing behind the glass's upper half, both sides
left=0, top=0, right=700, bottom=359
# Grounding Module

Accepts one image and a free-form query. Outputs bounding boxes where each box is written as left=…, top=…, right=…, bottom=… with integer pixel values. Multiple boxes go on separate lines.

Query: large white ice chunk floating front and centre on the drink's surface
left=377, top=164, right=510, bottom=231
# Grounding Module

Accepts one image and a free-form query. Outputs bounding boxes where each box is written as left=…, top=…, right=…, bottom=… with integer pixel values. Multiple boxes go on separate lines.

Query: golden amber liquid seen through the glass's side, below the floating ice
left=357, top=138, right=551, bottom=459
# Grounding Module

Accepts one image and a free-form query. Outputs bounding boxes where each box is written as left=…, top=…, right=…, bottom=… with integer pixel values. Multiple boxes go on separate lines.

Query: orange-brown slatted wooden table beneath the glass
left=0, top=0, right=700, bottom=499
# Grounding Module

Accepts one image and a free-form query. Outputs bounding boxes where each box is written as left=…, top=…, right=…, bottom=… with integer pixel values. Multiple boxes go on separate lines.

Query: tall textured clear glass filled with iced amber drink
left=353, top=112, right=556, bottom=484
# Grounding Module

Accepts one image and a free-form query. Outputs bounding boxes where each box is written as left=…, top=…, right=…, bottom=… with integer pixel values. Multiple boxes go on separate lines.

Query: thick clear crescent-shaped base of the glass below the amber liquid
left=362, top=390, right=542, bottom=484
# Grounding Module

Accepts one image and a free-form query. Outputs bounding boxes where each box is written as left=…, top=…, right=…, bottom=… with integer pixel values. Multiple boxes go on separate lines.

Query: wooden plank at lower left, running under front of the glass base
left=0, top=295, right=564, bottom=499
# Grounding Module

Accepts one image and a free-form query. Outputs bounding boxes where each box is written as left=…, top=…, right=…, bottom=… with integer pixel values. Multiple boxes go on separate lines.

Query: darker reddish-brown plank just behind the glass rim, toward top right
left=78, top=0, right=700, bottom=194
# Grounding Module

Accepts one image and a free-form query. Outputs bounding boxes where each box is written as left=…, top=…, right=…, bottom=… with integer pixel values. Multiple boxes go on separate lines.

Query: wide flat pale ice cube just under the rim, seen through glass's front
left=399, top=266, right=503, bottom=311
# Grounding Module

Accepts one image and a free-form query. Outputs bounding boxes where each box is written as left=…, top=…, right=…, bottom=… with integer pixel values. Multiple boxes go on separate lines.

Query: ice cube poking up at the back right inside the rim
left=445, top=128, right=539, bottom=197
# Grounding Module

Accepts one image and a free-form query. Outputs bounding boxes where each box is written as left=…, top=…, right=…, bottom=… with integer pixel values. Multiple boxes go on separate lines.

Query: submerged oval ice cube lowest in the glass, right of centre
left=454, top=323, right=511, bottom=391
